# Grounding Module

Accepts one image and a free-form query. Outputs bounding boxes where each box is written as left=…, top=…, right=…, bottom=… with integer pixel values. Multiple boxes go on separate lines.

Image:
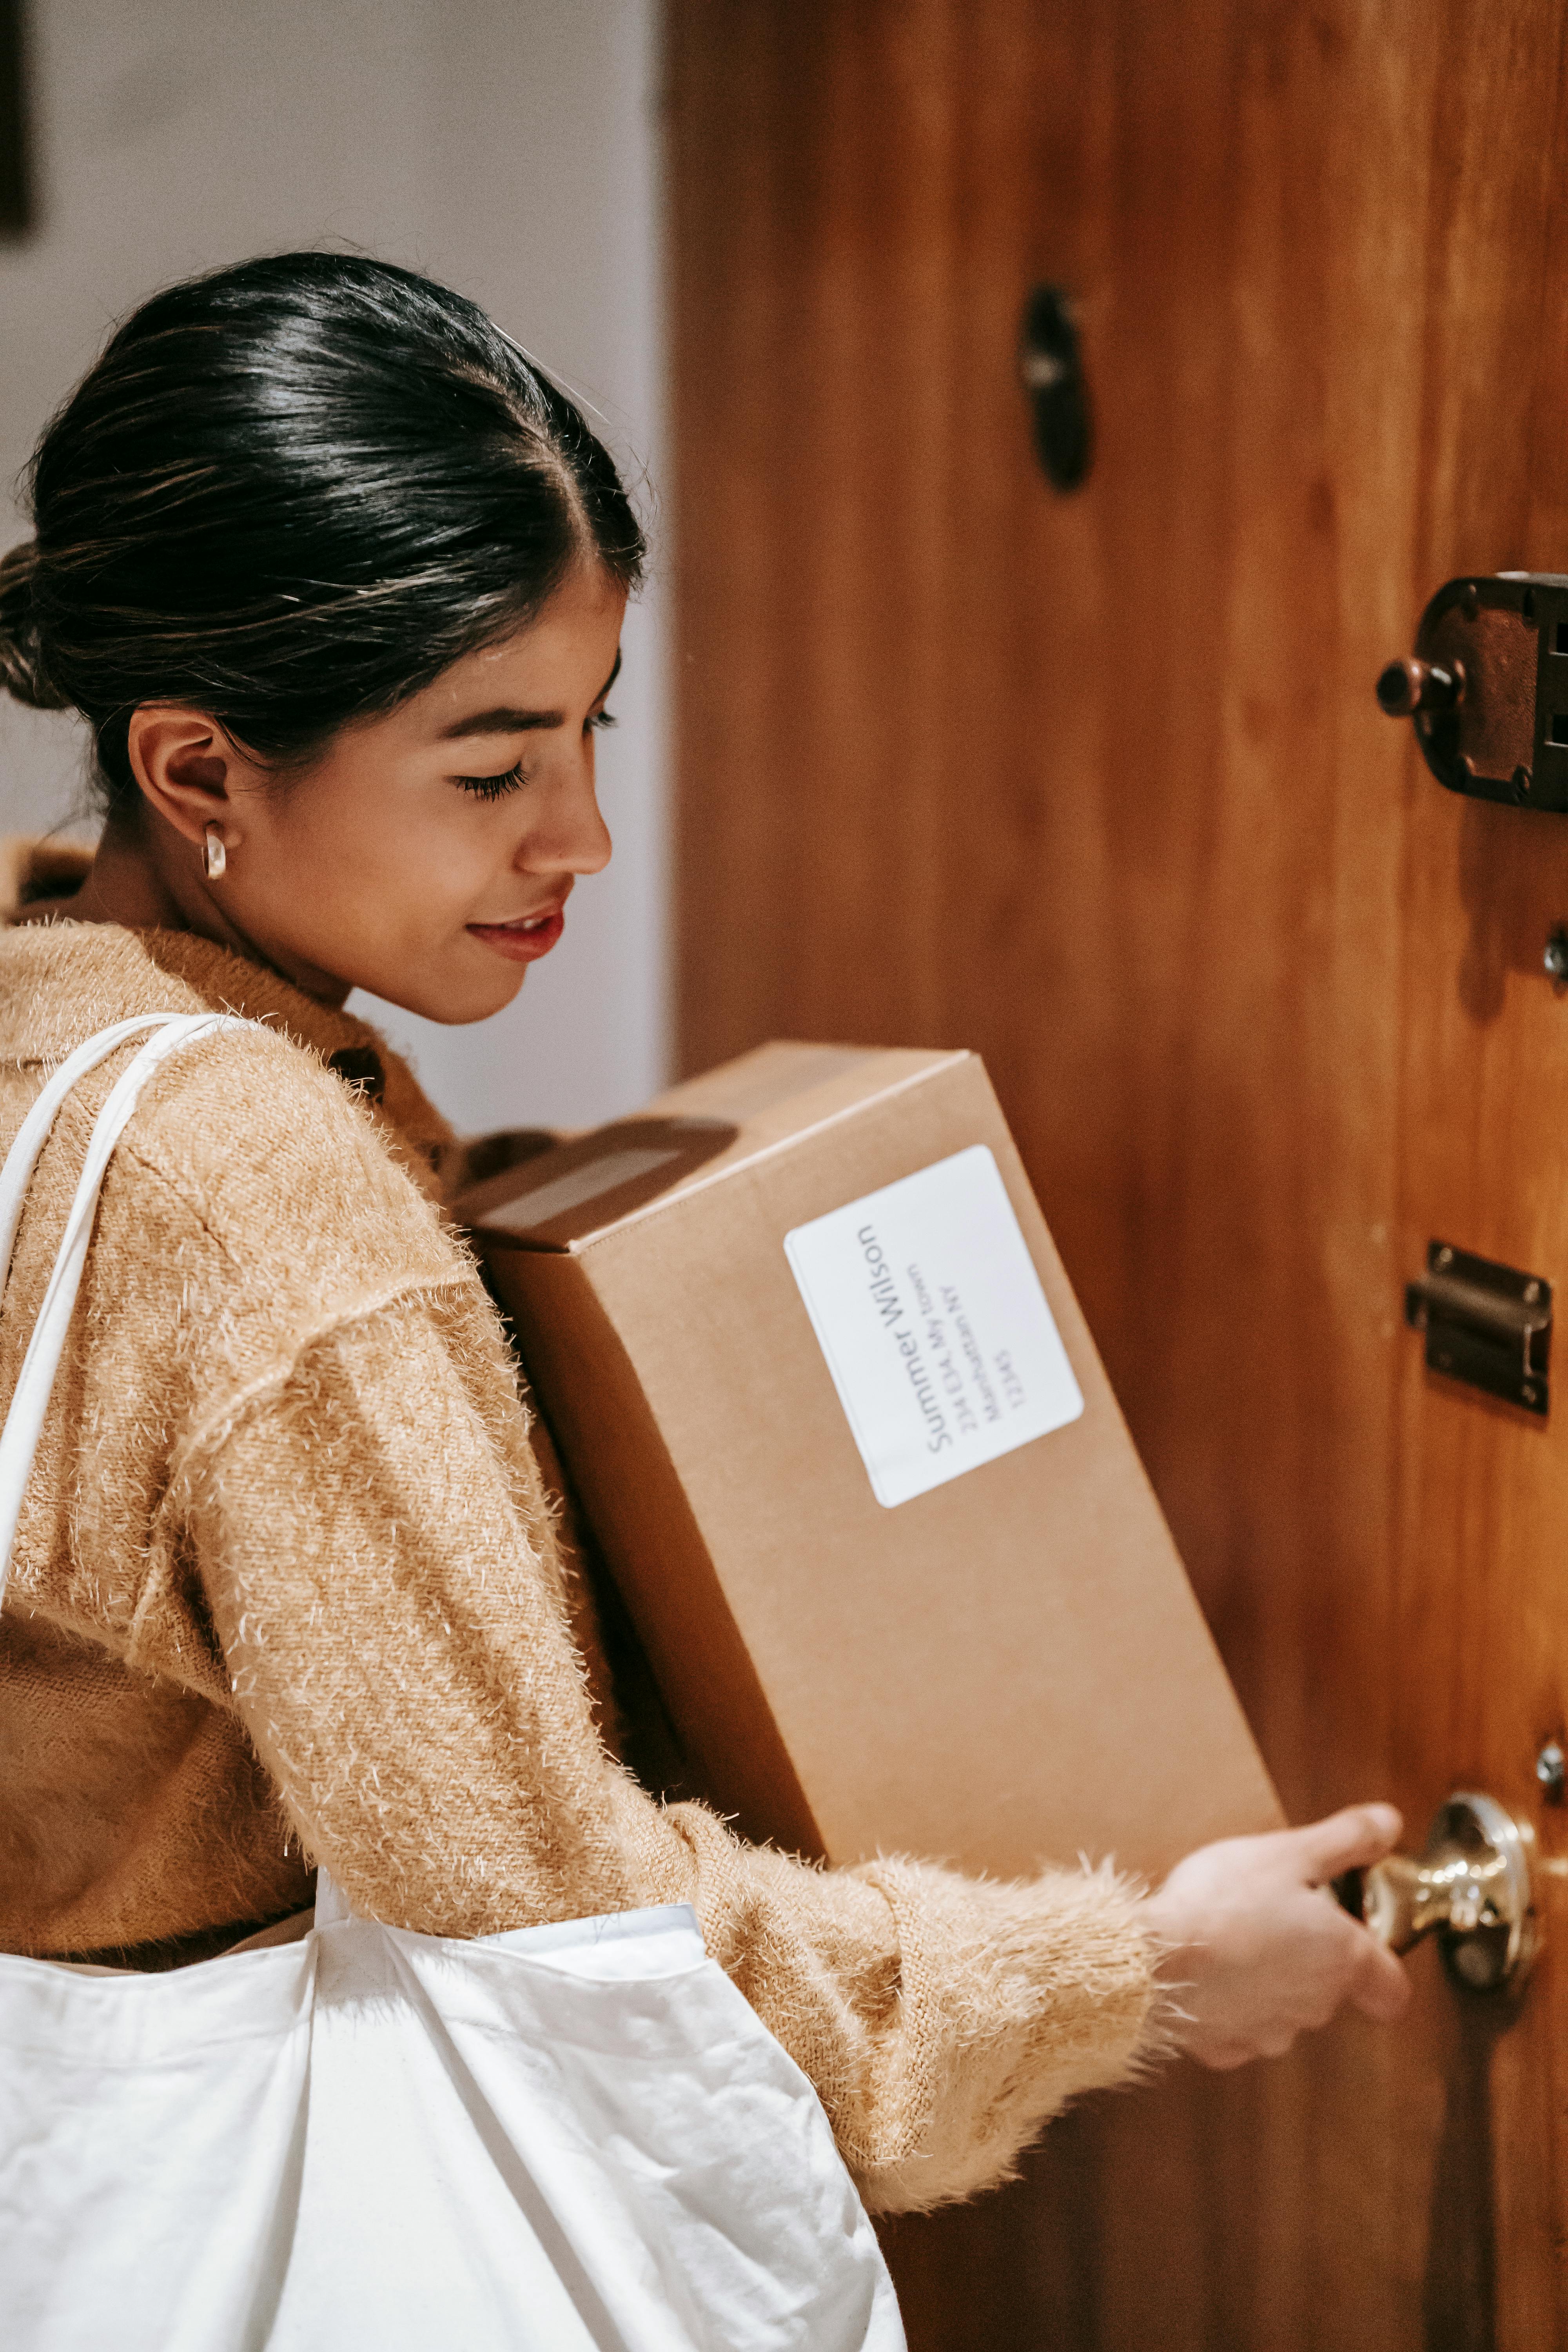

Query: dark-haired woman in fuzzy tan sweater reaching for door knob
left=0, top=254, right=1403, bottom=2286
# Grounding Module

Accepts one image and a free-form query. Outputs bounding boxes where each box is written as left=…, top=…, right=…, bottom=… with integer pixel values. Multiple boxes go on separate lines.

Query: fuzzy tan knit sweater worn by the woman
left=0, top=844, right=1152, bottom=2209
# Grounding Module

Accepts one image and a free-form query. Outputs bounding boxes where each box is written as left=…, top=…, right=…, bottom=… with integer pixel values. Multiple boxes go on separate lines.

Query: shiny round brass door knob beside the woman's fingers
left=1333, top=1790, right=1535, bottom=1992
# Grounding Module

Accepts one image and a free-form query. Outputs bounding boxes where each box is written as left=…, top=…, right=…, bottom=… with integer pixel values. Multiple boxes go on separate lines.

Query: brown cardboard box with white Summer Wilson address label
left=458, top=1044, right=1281, bottom=1875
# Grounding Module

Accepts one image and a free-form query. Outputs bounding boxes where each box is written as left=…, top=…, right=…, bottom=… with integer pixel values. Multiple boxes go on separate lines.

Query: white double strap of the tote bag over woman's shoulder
left=0, top=1014, right=254, bottom=1602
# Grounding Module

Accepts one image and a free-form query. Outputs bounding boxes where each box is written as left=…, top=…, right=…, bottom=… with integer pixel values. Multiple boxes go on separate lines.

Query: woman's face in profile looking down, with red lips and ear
left=132, top=564, right=625, bottom=1021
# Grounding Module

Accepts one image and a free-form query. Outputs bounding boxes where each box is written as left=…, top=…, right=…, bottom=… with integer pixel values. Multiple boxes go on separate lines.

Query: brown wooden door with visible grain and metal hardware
left=668, top=0, right=1568, bottom=2352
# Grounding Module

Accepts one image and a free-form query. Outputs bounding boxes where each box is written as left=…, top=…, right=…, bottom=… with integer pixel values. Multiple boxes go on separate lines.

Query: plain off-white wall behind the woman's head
left=0, top=0, right=665, bottom=1129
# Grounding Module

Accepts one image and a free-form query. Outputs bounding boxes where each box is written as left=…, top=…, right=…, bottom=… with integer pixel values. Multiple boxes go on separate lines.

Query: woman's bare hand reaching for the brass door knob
left=1143, top=1804, right=1410, bottom=2067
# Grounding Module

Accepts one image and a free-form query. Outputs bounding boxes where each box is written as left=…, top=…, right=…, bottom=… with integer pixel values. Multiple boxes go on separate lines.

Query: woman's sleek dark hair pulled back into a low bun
left=0, top=254, right=644, bottom=807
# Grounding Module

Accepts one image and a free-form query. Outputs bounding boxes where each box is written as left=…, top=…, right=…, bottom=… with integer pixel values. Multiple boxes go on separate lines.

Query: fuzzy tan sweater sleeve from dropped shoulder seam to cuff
left=184, top=1282, right=1152, bottom=2211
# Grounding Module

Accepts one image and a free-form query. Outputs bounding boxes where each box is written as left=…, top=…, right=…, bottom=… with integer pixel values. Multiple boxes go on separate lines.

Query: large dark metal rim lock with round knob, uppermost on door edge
left=1377, top=572, right=1568, bottom=809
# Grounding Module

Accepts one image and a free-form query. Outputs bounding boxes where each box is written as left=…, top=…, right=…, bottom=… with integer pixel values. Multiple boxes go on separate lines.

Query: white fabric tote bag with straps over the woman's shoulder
left=0, top=1014, right=903, bottom=2352
